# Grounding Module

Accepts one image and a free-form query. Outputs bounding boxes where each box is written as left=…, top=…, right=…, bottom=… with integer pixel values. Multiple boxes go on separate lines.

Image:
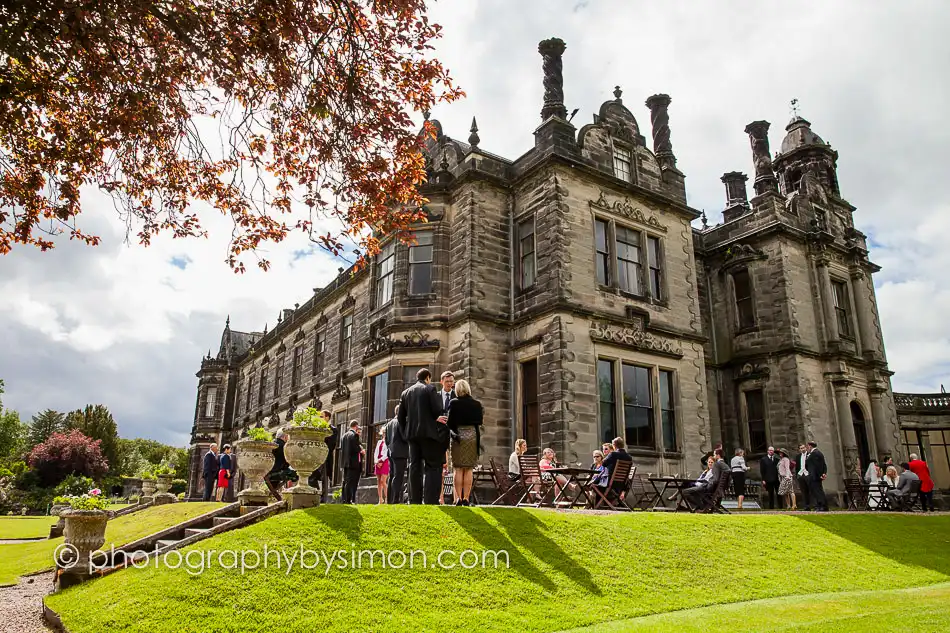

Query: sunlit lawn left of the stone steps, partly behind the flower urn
left=0, top=503, right=220, bottom=586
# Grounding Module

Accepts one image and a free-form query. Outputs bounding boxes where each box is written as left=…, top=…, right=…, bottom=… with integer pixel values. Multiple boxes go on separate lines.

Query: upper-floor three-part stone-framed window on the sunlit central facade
left=591, top=211, right=669, bottom=307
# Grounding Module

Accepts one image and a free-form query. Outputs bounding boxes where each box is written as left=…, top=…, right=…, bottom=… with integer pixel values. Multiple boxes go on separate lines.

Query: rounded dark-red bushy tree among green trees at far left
left=29, top=429, right=109, bottom=487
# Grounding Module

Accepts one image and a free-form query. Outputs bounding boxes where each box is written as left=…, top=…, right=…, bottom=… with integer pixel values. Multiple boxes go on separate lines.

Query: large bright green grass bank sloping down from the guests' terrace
left=47, top=505, right=950, bottom=633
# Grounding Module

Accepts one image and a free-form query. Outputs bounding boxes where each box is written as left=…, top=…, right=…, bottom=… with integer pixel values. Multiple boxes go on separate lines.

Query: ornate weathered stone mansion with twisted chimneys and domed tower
left=184, top=39, right=902, bottom=496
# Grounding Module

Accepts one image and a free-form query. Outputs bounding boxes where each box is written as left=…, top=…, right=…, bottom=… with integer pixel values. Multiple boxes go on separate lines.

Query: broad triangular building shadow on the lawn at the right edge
left=798, top=512, right=950, bottom=576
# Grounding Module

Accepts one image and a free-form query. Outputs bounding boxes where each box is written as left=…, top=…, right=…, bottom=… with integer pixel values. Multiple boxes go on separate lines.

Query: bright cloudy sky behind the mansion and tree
left=0, top=0, right=950, bottom=445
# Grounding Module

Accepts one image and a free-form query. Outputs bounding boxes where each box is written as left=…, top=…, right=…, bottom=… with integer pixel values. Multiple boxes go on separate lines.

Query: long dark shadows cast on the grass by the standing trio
left=443, top=508, right=601, bottom=596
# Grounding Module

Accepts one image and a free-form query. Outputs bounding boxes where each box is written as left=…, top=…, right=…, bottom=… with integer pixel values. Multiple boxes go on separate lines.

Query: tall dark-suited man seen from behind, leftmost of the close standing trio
left=398, top=369, right=454, bottom=505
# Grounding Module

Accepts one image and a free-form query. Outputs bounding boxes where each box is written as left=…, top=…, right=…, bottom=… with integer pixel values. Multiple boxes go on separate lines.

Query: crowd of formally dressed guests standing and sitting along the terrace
left=202, top=369, right=934, bottom=512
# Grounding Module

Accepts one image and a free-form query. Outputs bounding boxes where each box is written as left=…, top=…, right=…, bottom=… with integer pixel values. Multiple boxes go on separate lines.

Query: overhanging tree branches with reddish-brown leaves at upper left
left=0, top=0, right=462, bottom=271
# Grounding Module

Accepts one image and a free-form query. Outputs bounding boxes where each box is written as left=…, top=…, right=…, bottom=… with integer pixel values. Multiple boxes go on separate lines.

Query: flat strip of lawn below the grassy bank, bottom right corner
left=565, top=584, right=950, bottom=633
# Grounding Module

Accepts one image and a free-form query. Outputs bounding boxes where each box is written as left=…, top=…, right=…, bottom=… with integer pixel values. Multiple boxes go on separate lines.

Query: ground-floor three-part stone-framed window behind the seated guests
left=596, top=351, right=685, bottom=459
